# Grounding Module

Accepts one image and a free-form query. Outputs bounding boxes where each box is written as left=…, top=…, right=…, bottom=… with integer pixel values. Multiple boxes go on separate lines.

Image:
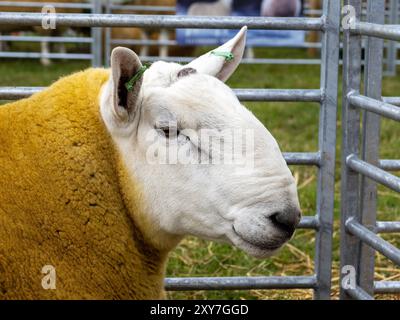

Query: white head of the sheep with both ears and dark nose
left=101, top=28, right=300, bottom=257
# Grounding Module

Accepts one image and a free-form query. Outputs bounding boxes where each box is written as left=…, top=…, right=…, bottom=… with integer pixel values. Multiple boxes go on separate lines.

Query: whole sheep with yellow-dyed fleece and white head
left=0, top=27, right=300, bottom=299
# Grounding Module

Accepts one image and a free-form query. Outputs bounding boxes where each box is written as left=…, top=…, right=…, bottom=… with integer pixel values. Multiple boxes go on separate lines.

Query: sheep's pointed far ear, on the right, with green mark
left=187, top=26, right=247, bottom=82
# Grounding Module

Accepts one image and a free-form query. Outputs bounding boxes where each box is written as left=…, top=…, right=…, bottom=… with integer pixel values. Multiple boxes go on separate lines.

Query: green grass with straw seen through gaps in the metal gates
left=0, top=49, right=400, bottom=299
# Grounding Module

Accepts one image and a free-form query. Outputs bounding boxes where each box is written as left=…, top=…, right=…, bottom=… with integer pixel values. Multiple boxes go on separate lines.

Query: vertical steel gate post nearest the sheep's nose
left=314, top=0, right=341, bottom=300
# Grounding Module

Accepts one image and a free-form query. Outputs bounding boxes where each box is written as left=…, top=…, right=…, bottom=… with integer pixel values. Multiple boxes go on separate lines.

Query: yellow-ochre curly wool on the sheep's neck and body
left=0, top=69, right=167, bottom=300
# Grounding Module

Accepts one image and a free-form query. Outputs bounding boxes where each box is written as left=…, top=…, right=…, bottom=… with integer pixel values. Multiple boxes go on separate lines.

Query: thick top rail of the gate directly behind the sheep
left=0, top=12, right=325, bottom=31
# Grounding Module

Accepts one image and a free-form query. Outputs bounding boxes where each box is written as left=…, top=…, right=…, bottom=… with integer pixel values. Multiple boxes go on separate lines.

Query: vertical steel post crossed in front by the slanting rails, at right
left=359, top=0, right=385, bottom=295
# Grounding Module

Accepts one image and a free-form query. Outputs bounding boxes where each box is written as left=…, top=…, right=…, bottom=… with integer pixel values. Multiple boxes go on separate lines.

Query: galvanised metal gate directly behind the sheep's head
left=0, top=0, right=341, bottom=299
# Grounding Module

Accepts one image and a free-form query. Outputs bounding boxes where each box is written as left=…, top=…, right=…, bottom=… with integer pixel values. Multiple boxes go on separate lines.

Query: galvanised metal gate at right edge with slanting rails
left=340, top=0, right=400, bottom=299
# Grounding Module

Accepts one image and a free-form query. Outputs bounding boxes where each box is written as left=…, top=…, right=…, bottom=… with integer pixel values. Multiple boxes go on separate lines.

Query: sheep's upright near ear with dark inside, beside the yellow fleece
left=110, top=47, right=142, bottom=120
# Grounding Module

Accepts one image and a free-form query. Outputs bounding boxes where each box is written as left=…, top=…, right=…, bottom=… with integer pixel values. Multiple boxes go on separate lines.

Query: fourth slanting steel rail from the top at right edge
left=346, top=218, right=400, bottom=266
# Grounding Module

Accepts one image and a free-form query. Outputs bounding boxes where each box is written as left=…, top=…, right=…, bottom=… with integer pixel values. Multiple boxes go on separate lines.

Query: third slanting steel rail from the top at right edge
left=346, top=154, right=400, bottom=192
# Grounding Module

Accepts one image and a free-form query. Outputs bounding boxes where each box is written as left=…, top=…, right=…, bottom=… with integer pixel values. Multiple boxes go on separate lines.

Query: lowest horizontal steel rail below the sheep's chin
left=165, top=276, right=317, bottom=291
